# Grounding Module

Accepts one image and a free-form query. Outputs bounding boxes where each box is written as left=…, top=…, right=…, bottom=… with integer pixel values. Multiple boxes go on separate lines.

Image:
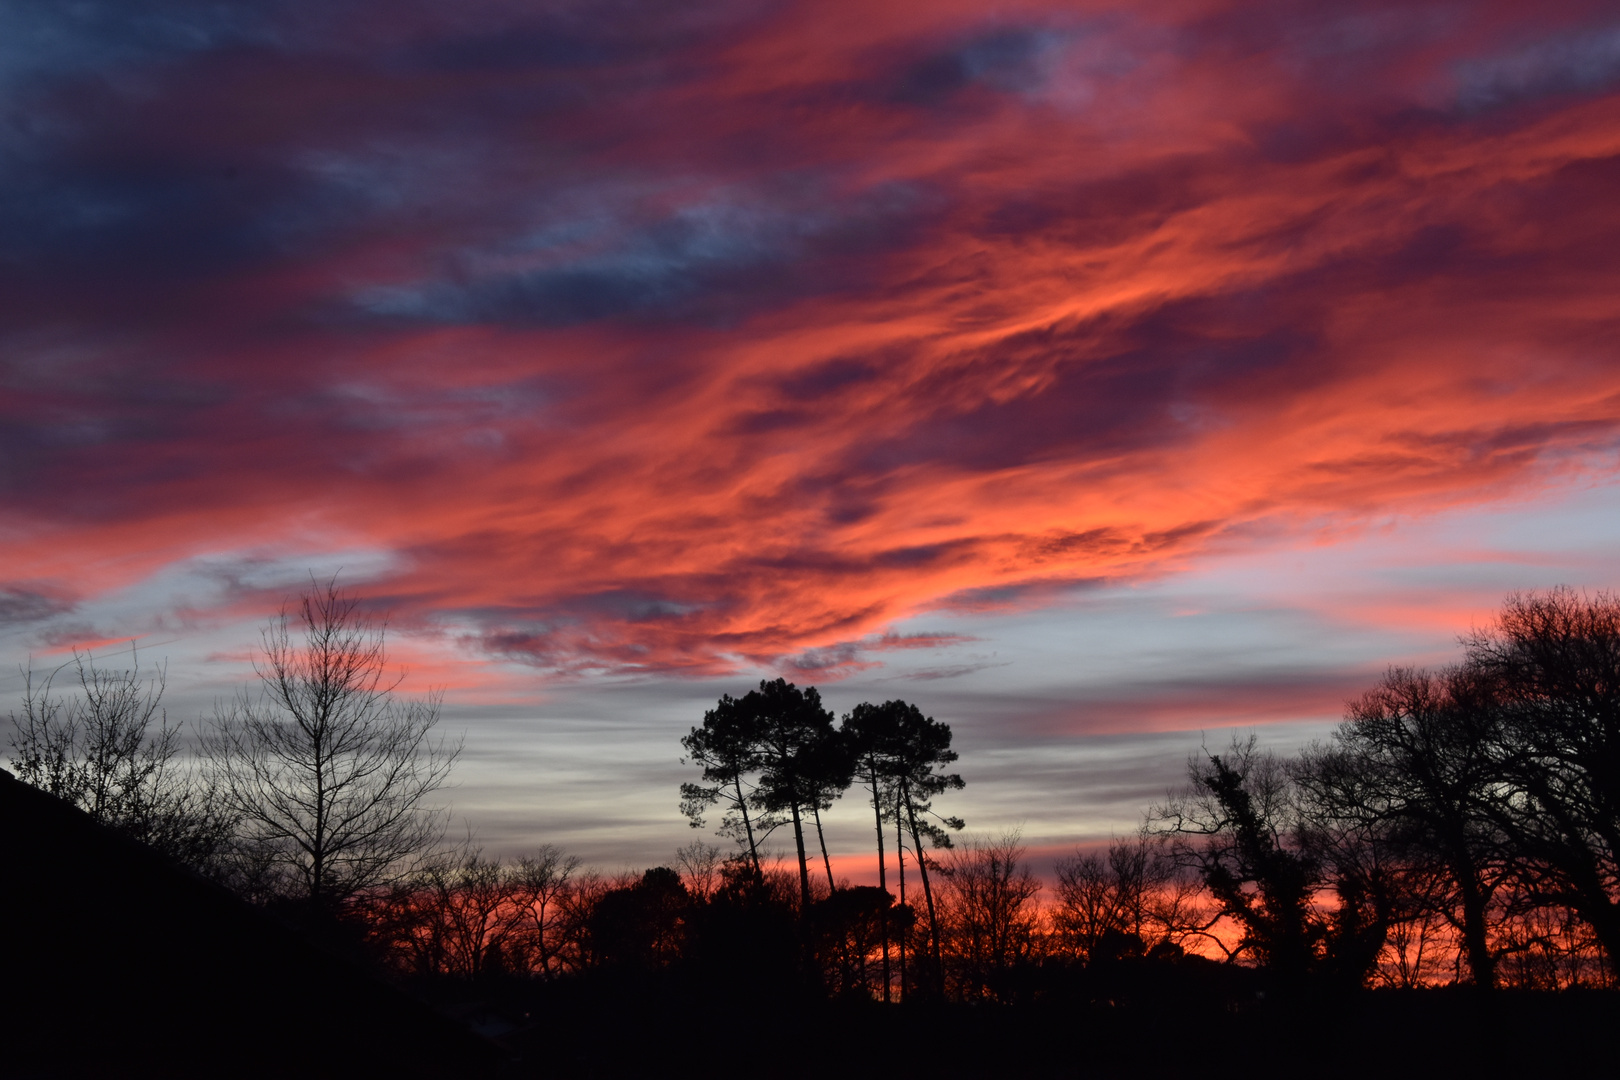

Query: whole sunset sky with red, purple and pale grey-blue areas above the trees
left=0, top=0, right=1620, bottom=879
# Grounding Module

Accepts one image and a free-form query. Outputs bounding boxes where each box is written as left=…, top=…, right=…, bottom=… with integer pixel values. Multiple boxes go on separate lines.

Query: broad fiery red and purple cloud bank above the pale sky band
left=0, top=3, right=1620, bottom=675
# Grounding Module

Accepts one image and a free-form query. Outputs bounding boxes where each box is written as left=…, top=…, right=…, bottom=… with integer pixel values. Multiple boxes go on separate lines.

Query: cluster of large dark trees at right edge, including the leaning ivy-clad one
left=1149, top=589, right=1620, bottom=988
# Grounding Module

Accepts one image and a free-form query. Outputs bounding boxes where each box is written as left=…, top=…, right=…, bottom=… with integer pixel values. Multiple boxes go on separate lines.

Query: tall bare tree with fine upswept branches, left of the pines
left=203, top=581, right=460, bottom=907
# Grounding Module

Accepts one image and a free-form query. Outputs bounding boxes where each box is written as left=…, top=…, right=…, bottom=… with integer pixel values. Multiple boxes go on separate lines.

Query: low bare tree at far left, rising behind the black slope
left=11, top=646, right=233, bottom=871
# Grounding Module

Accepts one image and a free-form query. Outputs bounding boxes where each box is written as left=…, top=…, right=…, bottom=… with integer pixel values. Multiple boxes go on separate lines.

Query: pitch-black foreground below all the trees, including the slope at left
left=0, top=772, right=1620, bottom=1080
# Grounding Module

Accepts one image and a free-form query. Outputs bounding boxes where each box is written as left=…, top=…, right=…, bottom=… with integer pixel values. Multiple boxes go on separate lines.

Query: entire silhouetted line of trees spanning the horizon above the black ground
left=13, top=585, right=1620, bottom=1002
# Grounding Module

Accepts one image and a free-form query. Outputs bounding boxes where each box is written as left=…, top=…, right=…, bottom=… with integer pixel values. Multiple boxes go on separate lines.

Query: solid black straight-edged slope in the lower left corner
left=0, top=769, right=501, bottom=1077
